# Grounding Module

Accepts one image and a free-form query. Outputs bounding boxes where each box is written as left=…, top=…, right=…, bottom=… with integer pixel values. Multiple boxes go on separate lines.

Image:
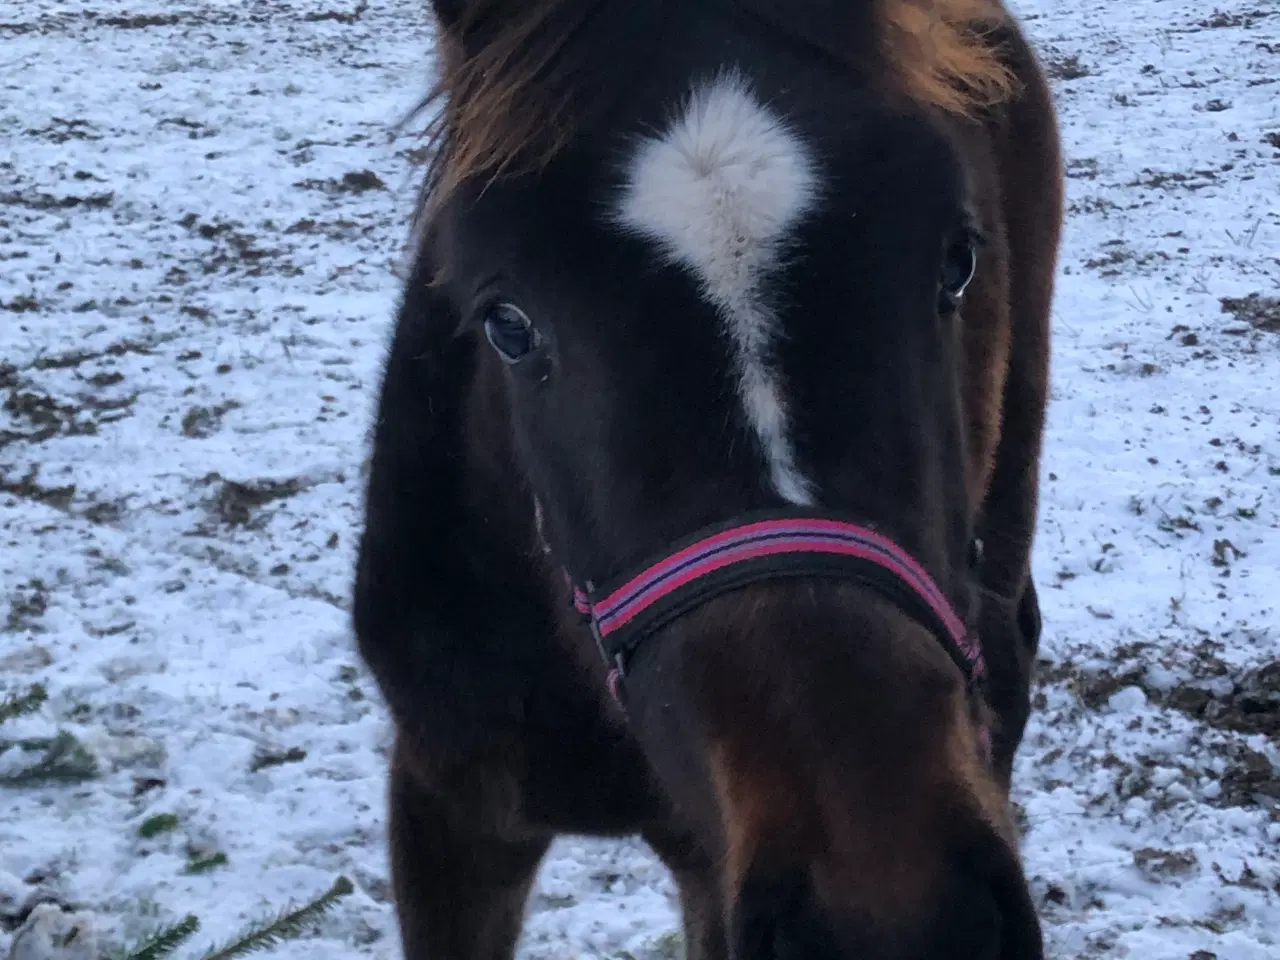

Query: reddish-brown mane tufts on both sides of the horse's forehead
left=415, top=0, right=1018, bottom=223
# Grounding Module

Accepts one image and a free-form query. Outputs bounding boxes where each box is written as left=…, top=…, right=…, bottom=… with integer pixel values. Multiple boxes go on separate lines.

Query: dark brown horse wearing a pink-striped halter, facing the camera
left=352, top=0, right=1062, bottom=960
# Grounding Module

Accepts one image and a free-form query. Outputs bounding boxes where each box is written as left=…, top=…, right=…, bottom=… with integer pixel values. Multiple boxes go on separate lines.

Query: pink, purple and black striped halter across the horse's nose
left=534, top=500, right=989, bottom=750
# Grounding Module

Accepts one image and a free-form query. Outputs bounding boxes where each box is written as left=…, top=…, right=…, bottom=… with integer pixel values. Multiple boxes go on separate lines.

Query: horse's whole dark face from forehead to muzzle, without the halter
left=433, top=47, right=1041, bottom=960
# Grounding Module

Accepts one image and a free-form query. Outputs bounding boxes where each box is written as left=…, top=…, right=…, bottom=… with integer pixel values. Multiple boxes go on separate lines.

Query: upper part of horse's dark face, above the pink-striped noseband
left=439, top=74, right=982, bottom=579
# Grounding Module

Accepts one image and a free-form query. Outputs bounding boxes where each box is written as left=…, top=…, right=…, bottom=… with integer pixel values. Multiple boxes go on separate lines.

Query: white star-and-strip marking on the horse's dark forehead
left=618, top=74, right=817, bottom=504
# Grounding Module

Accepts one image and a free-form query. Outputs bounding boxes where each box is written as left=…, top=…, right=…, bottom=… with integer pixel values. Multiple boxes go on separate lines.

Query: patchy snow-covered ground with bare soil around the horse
left=0, top=0, right=1280, bottom=960
